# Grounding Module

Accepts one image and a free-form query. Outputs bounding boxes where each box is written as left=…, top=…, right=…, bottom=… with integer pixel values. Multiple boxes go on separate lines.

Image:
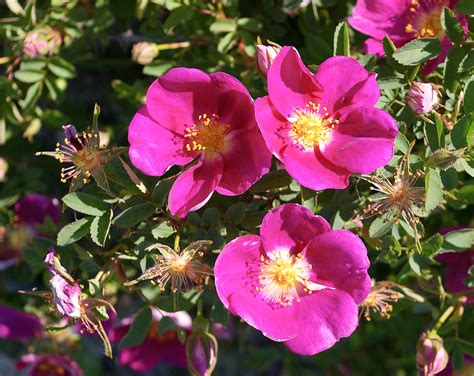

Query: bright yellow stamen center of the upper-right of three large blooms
left=289, top=102, right=339, bottom=151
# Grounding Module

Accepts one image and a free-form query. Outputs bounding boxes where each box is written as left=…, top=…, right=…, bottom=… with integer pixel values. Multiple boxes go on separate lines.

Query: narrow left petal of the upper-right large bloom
left=255, top=97, right=290, bottom=160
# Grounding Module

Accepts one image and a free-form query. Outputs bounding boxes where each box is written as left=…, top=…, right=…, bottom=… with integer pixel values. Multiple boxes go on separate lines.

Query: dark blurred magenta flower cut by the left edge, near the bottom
left=0, top=305, right=43, bottom=340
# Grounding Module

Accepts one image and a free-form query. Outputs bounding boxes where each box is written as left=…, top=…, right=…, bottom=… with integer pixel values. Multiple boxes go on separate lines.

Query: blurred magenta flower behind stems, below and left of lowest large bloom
left=109, top=307, right=192, bottom=372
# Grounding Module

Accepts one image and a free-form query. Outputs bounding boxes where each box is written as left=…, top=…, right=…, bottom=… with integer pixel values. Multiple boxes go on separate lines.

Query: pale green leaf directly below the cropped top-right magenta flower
left=393, top=38, right=441, bottom=65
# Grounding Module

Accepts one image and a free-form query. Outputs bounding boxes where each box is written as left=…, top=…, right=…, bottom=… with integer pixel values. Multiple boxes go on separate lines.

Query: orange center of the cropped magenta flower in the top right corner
left=405, top=0, right=444, bottom=39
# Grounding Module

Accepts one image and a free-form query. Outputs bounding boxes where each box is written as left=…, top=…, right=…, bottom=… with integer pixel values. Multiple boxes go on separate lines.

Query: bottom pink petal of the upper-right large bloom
left=283, top=145, right=350, bottom=191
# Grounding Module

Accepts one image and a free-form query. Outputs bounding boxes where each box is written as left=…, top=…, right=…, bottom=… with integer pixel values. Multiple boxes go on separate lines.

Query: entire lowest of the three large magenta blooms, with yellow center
left=214, top=204, right=371, bottom=355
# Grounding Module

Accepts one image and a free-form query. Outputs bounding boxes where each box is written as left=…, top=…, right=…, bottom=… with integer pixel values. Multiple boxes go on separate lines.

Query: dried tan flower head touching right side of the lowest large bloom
left=360, top=279, right=403, bottom=321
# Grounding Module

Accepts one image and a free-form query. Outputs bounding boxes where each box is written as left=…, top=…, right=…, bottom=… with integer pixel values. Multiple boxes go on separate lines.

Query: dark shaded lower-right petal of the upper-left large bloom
left=216, top=129, right=272, bottom=196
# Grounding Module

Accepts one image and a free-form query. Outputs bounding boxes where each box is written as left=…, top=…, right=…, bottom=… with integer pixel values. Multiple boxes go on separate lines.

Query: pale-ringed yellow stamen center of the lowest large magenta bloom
left=256, top=250, right=313, bottom=306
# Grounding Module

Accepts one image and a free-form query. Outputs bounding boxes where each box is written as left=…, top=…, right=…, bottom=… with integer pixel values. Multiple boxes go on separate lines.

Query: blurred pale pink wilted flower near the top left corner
left=23, top=26, right=62, bottom=57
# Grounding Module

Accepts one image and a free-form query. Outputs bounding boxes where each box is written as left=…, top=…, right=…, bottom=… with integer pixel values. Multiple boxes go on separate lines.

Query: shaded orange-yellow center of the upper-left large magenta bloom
left=184, top=114, right=229, bottom=156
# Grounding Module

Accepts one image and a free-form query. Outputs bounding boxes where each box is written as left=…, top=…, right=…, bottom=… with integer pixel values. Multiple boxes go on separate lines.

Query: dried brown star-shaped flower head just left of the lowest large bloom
left=125, top=240, right=213, bottom=292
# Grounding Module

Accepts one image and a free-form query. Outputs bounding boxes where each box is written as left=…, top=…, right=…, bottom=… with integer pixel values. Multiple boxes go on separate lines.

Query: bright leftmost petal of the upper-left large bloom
left=128, top=106, right=197, bottom=176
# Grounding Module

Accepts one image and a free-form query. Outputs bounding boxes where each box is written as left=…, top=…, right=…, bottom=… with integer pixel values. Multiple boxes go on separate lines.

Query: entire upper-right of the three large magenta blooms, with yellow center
left=255, top=47, right=398, bottom=190
